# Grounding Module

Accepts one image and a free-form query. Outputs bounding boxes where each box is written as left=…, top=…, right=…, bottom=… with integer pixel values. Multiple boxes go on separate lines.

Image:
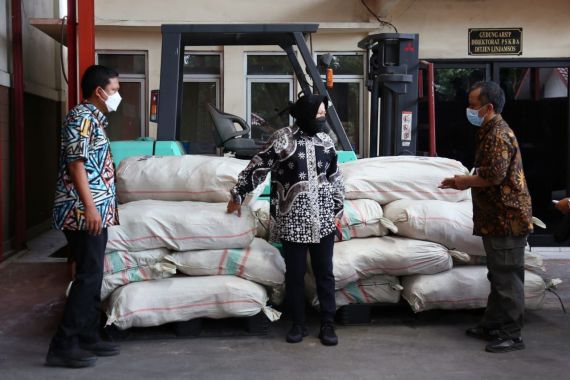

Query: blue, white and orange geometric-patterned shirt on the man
left=53, top=103, right=119, bottom=230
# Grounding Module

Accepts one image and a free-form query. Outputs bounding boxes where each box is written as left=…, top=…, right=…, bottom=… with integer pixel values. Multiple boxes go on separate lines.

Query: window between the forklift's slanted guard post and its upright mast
left=317, top=52, right=364, bottom=155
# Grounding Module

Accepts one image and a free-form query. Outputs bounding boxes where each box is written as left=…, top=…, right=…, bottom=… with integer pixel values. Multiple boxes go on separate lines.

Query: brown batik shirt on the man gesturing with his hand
left=471, top=115, right=532, bottom=236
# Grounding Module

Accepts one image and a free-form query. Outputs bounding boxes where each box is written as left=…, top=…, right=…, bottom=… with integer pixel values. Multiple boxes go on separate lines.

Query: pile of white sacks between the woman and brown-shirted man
left=306, top=156, right=556, bottom=312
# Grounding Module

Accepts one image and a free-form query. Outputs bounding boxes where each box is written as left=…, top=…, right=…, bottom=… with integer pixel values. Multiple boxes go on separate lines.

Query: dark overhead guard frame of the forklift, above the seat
left=157, top=24, right=353, bottom=151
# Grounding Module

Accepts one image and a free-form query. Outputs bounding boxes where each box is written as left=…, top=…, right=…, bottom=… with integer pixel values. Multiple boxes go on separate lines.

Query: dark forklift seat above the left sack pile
left=207, top=103, right=264, bottom=159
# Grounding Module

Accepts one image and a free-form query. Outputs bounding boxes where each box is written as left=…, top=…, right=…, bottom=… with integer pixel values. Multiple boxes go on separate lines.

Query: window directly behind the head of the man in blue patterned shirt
left=97, top=51, right=147, bottom=140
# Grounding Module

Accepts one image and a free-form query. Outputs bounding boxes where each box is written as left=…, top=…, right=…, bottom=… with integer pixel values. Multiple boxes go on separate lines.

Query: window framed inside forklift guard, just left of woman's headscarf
left=246, top=53, right=295, bottom=141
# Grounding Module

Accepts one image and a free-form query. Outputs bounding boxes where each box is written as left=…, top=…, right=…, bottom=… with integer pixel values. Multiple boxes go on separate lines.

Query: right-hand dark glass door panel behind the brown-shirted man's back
left=495, top=62, right=570, bottom=245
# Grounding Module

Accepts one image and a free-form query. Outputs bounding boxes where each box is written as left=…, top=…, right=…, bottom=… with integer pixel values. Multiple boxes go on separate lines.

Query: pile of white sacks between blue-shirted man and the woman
left=101, top=156, right=285, bottom=329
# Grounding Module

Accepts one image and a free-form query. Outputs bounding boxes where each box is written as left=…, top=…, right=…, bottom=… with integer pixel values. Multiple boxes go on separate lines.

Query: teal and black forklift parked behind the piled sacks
left=112, top=24, right=435, bottom=163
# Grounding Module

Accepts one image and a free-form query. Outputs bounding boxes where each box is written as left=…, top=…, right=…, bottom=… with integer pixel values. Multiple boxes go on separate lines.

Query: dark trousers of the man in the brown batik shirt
left=481, top=236, right=526, bottom=338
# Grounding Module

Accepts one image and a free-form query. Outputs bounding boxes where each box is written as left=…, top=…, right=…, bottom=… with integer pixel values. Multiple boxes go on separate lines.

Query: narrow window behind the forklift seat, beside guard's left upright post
left=179, top=53, right=221, bottom=154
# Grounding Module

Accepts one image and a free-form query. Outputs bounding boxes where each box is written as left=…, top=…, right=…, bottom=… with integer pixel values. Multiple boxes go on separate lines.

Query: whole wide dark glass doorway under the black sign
left=426, top=60, right=570, bottom=246
